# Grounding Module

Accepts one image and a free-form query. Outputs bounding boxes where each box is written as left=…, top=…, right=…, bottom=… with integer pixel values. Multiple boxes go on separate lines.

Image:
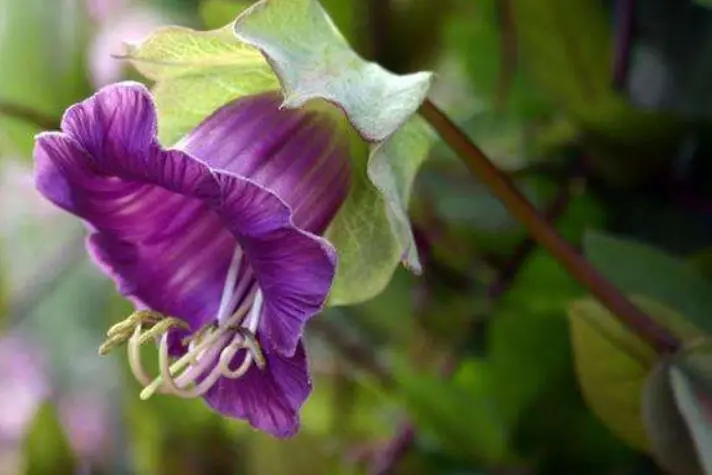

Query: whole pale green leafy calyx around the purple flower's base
left=128, top=0, right=432, bottom=305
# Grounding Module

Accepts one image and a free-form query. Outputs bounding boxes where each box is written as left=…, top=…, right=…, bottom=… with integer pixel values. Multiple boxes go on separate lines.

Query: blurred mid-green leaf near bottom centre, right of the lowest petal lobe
left=394, top=360, right=508, bottom=464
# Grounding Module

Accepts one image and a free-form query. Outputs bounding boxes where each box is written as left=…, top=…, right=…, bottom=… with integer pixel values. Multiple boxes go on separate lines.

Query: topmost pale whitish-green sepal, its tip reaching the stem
left=235, top=0, right=432, bottom=142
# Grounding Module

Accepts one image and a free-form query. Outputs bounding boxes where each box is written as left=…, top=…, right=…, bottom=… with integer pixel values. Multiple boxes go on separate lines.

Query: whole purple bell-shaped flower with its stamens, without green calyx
left=34, top=82, right=350, bottom=437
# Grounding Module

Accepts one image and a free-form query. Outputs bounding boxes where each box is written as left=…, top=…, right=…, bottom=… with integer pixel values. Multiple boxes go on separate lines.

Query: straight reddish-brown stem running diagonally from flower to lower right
left=420, top=100, right=680, bottom=353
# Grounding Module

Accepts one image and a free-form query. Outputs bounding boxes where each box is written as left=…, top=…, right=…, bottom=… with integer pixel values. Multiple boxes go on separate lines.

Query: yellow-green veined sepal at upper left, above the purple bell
left=127, top=26, right=279, bottom=144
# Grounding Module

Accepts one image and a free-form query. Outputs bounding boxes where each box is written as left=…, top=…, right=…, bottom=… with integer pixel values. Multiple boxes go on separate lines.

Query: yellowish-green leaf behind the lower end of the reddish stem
left=569, top=297, right=695, bottom=450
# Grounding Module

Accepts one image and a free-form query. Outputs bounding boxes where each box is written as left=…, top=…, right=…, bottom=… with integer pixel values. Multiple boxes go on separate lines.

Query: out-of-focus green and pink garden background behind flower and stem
left=0, top=0, right=712, bottom=475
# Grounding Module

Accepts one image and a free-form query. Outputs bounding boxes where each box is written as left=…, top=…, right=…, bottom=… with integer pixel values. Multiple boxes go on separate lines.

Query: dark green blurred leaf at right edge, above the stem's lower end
left=583, top=232, right=712, bottom=337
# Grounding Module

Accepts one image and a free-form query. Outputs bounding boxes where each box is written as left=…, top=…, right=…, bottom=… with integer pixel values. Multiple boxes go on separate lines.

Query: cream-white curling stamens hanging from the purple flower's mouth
left=128, top=247, right=266, bottom=399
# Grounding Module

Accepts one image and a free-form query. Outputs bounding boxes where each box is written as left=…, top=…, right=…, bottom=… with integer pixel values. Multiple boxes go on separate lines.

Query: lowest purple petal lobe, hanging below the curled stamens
left=205, top=342, right=312, bottom=437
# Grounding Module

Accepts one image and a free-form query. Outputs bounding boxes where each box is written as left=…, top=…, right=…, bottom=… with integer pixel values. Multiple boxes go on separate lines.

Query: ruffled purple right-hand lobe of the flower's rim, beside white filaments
left=216, top=173, right=336, bottom=356
